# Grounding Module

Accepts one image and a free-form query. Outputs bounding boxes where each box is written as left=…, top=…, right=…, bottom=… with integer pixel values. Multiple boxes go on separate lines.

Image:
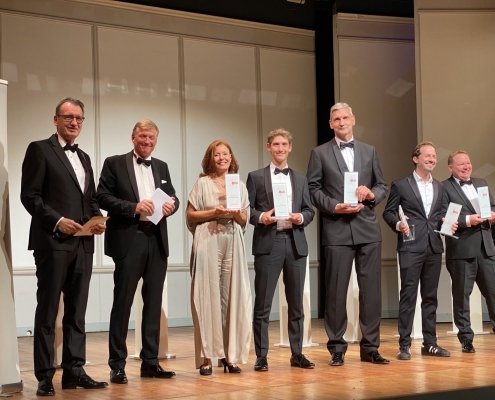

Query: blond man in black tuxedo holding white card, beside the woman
left=96, top=119, right=179, bottom=383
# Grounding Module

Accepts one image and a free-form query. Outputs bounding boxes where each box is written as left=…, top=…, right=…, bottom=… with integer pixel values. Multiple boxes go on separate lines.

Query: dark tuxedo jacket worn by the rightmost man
left=442, top=176, right=495, bottom=260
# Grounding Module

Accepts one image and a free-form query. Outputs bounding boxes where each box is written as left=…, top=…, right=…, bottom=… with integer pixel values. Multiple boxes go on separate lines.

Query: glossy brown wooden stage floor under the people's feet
left=13, top=319, right=495, bottom=400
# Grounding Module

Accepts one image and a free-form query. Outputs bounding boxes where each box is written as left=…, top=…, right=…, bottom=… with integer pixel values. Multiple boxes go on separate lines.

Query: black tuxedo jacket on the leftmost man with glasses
left=21, top=134, right=101, bottom=253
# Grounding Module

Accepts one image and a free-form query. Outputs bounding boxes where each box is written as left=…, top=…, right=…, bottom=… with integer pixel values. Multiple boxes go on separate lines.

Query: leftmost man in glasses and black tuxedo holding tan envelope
left=21, top=98, right=107, bottom=396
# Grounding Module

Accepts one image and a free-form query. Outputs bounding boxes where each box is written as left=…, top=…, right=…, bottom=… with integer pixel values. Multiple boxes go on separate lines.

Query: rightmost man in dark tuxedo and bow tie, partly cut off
left=442, top=150, right=495, bottom=353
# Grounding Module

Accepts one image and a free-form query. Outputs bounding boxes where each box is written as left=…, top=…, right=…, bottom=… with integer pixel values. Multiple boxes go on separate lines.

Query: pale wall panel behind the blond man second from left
left=98, top=28, right=185, bottom=266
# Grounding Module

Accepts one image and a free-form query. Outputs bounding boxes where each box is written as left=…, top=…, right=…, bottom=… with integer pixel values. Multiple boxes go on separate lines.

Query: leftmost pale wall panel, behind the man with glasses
left=0, top=14, right=94, bottom=269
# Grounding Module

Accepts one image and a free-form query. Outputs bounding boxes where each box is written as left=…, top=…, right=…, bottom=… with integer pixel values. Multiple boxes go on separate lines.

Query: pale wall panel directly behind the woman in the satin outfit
left=184, top=39, right=258, bottom=260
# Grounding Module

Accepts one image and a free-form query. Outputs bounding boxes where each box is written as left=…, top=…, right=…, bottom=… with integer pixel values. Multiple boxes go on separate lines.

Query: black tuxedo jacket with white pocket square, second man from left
left=96, top=151, right=180, bottom=260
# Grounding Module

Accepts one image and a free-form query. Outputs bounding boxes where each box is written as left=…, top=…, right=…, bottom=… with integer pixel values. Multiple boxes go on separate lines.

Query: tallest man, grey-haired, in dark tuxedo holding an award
left=307, top=103, right=389, bottom=366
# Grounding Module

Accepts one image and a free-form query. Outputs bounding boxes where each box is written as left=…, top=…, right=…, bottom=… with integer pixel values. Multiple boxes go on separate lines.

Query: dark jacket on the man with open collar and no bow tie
left=383, top=174, right=443, bottom=254
